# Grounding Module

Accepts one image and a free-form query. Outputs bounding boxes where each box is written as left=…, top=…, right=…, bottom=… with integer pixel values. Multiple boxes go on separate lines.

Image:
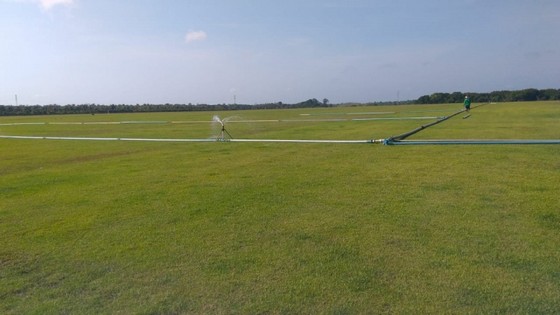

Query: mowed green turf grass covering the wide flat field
left=0, top=103, right=560, bottom=314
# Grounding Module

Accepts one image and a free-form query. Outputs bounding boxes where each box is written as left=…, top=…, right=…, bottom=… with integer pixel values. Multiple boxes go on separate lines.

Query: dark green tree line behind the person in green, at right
left=416, top=89, right=560, bottom=104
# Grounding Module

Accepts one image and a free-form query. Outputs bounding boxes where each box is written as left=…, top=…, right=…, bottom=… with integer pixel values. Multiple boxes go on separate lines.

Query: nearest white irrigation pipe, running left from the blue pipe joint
left=0, top=135, right=383, bottom=143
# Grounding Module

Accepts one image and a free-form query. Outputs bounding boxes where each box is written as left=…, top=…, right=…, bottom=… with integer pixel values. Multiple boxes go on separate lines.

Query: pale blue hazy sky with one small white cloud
left=0, top=0, right=560, bottom=105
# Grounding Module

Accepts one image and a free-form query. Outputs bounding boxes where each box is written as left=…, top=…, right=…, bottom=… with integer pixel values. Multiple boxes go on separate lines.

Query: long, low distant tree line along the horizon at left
left=0, top=98, right=332, bottom=116
